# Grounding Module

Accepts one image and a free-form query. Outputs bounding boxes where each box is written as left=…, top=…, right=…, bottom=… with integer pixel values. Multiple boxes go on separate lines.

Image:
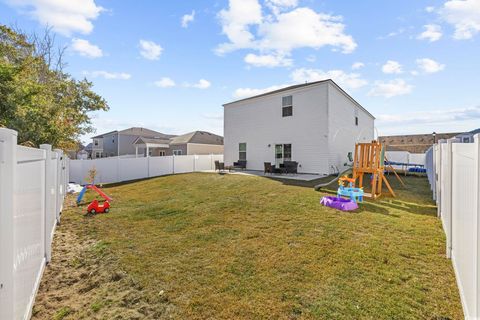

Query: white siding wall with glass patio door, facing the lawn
left=224, top=84, right=329, bottom=174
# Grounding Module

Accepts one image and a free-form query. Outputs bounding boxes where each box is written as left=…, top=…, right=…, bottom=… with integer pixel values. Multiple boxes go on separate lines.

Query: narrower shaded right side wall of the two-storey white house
left=328, top=83, right=374, bottom=173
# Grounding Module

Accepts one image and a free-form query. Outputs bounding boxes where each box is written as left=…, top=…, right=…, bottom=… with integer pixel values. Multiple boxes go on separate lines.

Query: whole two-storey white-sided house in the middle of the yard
left=224, top=79, right=375, bottom=174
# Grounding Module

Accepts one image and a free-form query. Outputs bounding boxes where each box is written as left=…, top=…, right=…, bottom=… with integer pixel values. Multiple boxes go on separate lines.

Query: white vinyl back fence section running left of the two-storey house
left=70, top=154, right=223, bottom=184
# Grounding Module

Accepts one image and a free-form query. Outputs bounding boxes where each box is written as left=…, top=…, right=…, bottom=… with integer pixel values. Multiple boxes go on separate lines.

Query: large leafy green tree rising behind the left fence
left=0, top=25, right=108, bottom=149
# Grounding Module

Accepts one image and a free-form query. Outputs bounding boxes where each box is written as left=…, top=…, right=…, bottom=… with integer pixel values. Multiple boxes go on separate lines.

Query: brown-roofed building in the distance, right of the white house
left=378, top=132, right=458, bottom=153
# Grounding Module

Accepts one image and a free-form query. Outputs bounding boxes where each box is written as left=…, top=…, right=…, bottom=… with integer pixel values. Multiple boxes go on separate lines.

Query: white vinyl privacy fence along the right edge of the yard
left=427, top=135, right=480, bottom=319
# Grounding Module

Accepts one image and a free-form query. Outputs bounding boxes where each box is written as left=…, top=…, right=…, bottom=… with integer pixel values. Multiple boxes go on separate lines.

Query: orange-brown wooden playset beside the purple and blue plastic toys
left=352, top=141, right=404, bottom=199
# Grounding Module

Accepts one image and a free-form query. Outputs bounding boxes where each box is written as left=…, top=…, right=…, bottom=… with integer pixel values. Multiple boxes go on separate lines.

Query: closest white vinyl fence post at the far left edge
left=0, top=128, right=17, bottom=319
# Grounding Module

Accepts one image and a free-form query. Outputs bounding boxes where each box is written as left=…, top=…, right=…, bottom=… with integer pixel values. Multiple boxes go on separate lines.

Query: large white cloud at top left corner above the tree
left=7, top=0, right=104, bottom=36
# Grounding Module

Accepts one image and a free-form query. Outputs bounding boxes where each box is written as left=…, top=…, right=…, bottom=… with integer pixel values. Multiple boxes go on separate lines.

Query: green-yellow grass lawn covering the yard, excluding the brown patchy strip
left=43, top=173, right=463, bottom=319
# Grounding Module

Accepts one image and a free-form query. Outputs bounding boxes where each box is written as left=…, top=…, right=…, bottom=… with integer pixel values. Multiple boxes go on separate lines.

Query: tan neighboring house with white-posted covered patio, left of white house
left=133, top=131, right=223, bottom=156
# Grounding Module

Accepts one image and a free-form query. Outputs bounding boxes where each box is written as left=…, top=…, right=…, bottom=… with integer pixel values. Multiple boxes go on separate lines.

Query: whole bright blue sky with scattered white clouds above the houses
left=0, top=0, right=480, bottom=140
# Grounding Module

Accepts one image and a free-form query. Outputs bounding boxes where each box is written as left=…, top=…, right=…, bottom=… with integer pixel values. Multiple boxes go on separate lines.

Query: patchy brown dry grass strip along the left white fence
left=32, top=197, right=169, bottom=320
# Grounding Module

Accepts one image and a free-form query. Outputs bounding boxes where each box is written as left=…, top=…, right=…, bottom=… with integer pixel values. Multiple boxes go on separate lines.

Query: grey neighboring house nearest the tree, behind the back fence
left=92, top=127, right=174, bottom=159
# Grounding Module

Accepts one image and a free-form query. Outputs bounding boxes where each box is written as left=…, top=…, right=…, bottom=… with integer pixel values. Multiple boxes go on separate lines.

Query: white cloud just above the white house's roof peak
left=290, top=68, right=368, bottom=89
